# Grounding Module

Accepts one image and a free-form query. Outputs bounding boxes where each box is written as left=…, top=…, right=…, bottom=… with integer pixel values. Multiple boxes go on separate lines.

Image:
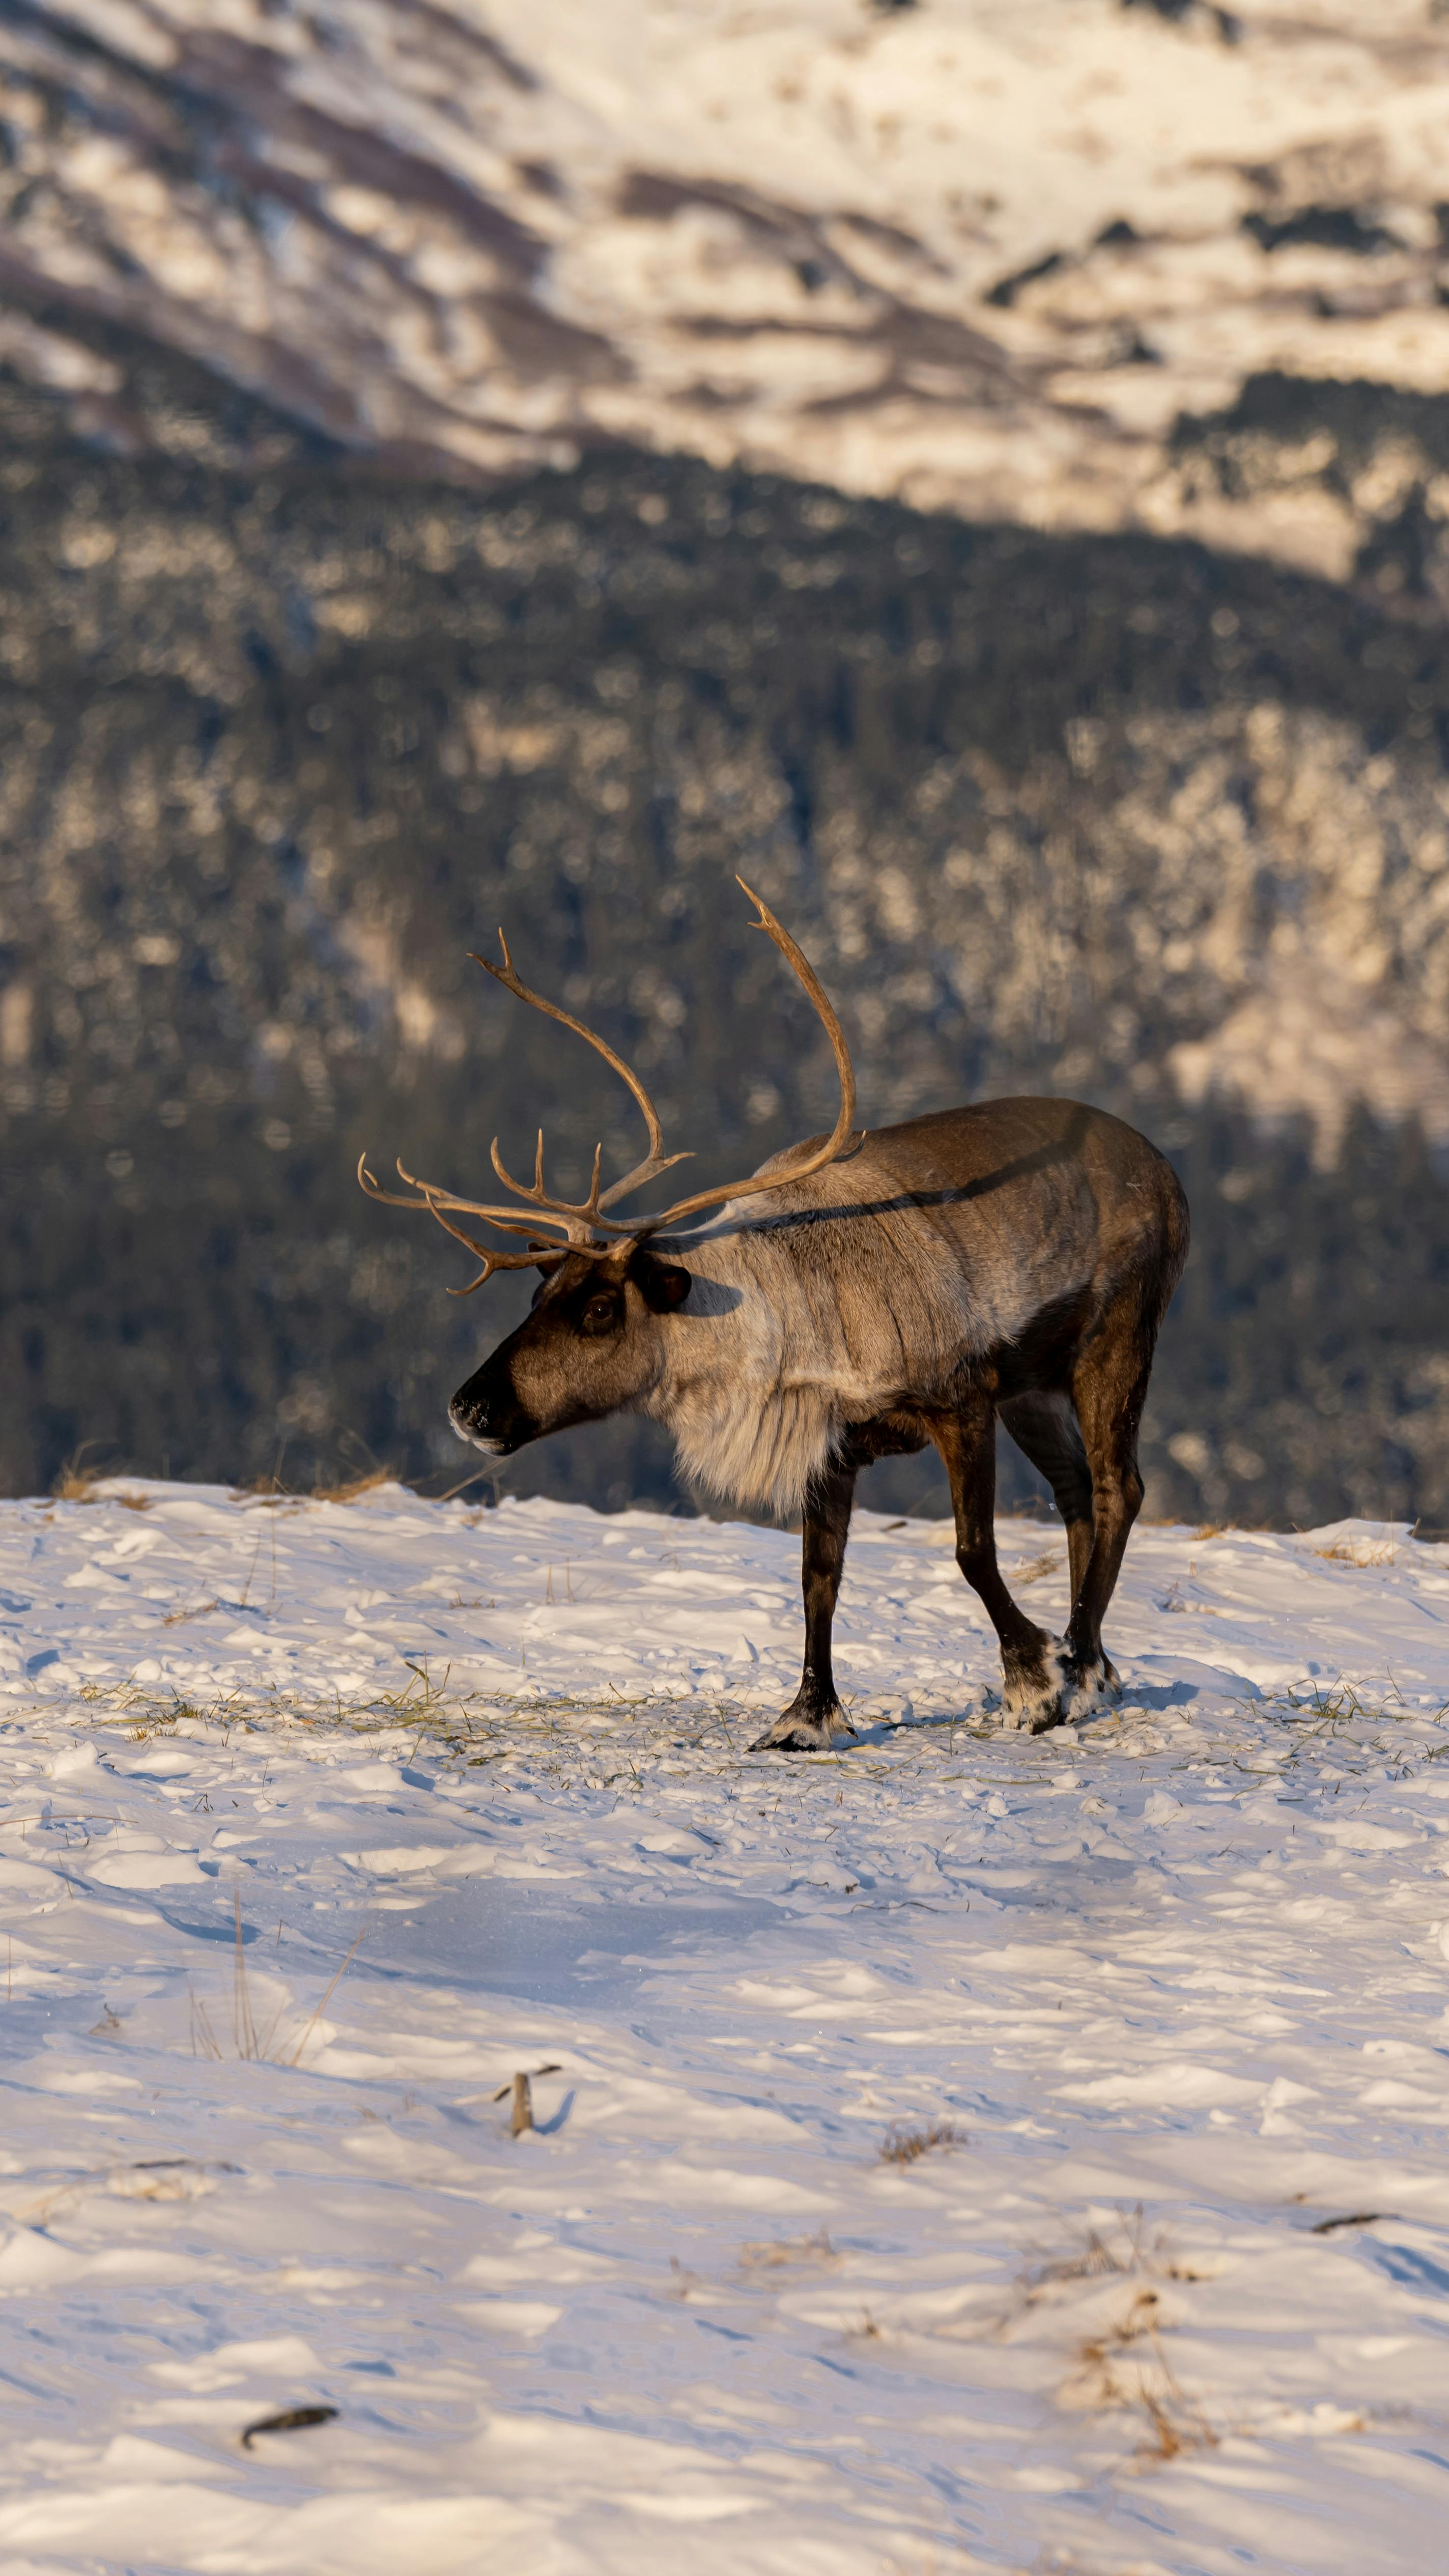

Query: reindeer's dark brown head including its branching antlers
left=358, top=879, right=855, bottom=1458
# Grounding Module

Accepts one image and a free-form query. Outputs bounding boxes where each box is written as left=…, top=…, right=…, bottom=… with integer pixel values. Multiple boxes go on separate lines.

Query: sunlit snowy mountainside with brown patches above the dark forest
left=0, top=0, right=1449, bottom=577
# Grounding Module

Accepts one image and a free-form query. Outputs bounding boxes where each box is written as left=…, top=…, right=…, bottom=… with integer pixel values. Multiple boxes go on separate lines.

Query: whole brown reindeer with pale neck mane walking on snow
left=358, top=879, right=1189, bottom=1751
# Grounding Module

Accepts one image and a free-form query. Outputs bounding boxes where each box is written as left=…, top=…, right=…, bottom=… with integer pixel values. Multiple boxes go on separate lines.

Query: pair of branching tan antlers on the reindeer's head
left=358, top=876, right=855, bottom=1296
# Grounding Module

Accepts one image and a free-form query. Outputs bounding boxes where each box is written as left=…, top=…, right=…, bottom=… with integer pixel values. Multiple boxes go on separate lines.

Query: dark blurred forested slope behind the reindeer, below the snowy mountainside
left=0, top=353, right=1449, bottom=1522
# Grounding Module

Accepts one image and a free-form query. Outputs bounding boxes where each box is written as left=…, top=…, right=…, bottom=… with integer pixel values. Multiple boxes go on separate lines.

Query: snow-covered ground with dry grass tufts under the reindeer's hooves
left=0, top=1484, right=1449, bottom=2576
